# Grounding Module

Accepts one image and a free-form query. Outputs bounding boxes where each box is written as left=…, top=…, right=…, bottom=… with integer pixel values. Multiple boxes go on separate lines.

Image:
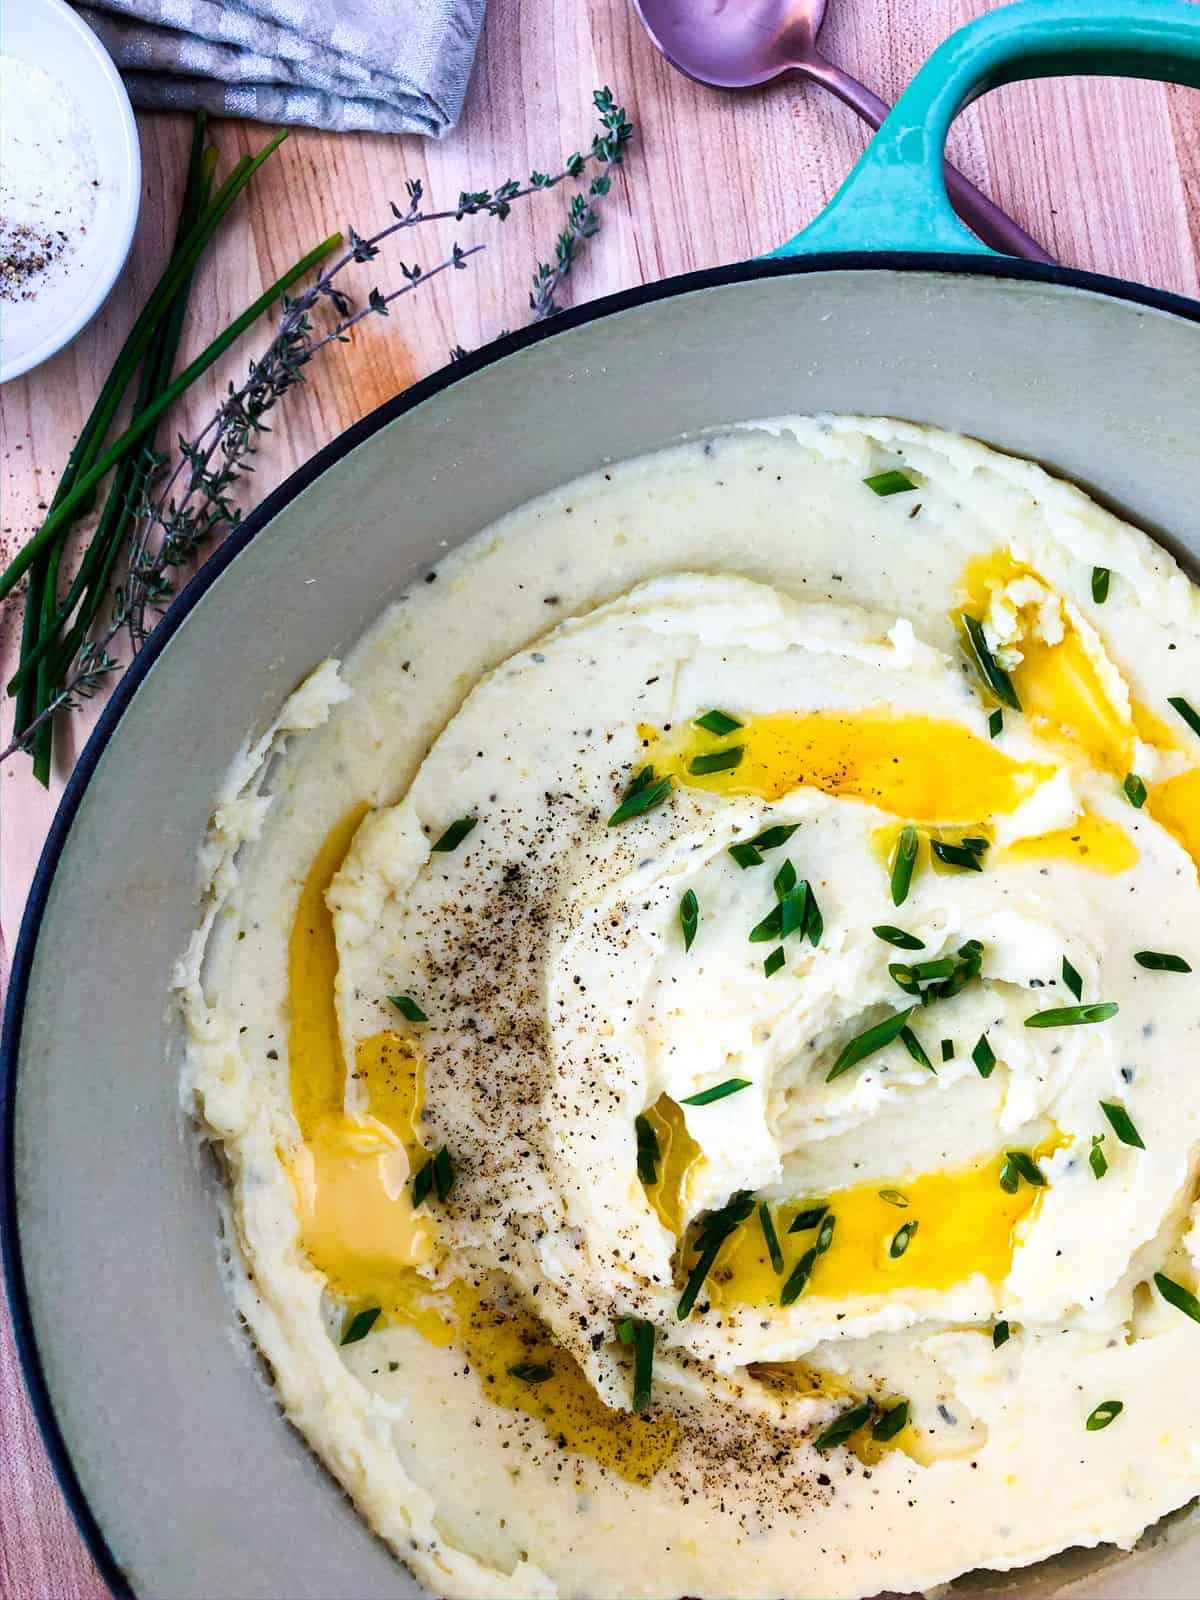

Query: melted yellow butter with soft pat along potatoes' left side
left=280, top=806, right=686, bottom=1483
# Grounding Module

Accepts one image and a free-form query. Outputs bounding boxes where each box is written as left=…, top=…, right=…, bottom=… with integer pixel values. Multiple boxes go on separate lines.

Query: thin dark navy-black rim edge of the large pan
left=0, top=251, right=1200, bottom=1600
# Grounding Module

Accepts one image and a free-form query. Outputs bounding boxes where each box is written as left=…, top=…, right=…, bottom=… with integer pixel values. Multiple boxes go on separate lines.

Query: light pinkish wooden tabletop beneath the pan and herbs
left=0, top=0, right=1200, bottom=1600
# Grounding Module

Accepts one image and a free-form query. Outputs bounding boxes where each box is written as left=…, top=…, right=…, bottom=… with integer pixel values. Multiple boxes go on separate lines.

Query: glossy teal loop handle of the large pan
left=771, top=0, right=1200, bottom=256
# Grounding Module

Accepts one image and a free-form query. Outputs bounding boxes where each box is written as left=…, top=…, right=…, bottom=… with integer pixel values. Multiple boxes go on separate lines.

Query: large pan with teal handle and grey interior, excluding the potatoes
left=0, top=0, right=1200, bottom=1600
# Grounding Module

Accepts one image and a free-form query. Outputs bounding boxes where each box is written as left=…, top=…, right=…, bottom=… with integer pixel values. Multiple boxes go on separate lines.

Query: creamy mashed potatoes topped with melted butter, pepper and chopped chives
left=179, top=418, right=1200, bottom=1597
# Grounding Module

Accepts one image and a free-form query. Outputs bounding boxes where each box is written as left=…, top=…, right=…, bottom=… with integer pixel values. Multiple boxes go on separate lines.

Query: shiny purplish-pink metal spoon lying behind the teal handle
left=634, top=0, right=1054, bottom=261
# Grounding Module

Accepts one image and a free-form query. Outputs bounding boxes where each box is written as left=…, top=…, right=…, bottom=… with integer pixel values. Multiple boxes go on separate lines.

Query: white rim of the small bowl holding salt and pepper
left=0, top=0, right=142, bottom=384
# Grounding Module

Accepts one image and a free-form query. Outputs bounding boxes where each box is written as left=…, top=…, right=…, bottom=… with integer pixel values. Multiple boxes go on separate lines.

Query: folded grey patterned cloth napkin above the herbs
left=77, top=0, right=485, bottom=138
